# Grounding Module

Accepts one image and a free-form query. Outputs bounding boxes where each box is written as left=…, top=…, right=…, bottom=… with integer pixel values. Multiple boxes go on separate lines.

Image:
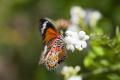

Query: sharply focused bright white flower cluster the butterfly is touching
left=64, top=30, right=89, bottom=52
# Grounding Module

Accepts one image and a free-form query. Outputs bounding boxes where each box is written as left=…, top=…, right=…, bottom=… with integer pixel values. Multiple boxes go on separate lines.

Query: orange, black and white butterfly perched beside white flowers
left=39, top=18, right=66, bottom=70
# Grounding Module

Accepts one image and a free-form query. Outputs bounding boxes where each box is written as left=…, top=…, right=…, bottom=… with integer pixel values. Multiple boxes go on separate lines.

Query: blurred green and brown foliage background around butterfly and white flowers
left=0, top=0, right=120, bottom=80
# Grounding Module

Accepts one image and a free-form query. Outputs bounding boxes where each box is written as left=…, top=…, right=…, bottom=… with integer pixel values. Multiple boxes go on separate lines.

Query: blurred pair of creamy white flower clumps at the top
left=70, top=6, right=102, bottom=26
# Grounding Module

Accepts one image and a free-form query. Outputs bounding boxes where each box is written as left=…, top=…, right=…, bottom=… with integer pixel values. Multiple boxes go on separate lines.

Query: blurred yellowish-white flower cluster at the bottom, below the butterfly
left=61, top=66, right=82, bottom=80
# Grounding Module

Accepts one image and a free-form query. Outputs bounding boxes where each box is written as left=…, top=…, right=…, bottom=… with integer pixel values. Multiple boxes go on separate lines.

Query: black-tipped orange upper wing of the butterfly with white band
left=40, top=18, right=59, bottom=45
